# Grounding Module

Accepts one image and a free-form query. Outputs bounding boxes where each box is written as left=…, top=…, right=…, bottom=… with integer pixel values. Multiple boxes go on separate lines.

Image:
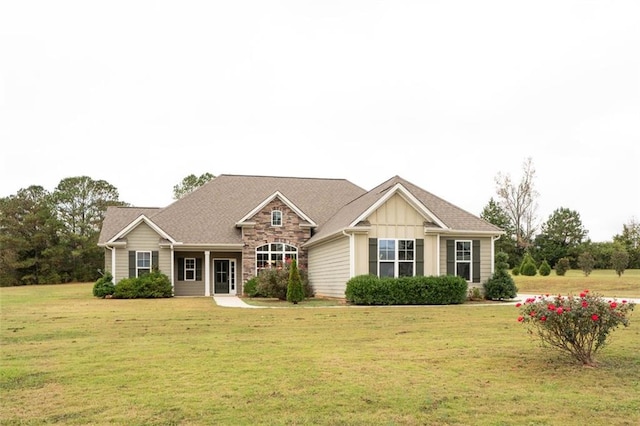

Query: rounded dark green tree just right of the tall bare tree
left=535, top=207, right=587, bottom=267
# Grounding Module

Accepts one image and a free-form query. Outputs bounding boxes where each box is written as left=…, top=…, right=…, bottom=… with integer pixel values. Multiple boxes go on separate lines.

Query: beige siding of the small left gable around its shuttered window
left=113, top=222, right=171, bottom=283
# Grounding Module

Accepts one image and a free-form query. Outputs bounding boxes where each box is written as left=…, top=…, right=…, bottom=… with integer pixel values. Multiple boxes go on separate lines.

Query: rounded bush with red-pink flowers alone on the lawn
left=516, top=290, right=635, bottom=366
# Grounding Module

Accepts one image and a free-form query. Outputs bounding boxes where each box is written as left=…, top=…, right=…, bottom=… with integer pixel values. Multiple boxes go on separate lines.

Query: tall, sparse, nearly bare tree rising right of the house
left=495, top=157, right=538, bottom=253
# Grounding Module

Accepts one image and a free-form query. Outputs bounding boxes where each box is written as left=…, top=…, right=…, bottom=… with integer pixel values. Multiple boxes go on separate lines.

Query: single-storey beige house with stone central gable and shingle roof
left=98, top=175, right=503, bottom=297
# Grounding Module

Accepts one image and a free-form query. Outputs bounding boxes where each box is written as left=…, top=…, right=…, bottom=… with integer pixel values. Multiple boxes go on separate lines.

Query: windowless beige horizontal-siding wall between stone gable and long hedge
left=309, top=237, right=351, bottom=298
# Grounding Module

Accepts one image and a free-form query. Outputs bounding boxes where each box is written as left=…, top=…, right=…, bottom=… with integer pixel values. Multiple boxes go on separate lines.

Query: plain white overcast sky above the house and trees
left=0, top=0, right=640, bottom=241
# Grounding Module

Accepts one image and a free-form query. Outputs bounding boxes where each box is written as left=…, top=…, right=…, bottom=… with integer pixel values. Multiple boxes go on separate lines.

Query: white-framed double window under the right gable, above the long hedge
left=378, top=239, right=415, bottom=277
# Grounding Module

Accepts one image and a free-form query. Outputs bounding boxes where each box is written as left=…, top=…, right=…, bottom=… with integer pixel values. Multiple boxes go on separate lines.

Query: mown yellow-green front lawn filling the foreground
left=0, top=277, right=640, bottom=425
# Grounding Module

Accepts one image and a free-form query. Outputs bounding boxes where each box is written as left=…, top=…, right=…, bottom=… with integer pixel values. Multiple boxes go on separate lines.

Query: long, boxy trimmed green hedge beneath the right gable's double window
left=345, top=275, right=468, bottom=305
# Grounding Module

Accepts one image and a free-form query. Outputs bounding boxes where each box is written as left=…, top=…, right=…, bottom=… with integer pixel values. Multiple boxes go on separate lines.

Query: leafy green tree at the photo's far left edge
left=0, top=185, right=61, bottom=286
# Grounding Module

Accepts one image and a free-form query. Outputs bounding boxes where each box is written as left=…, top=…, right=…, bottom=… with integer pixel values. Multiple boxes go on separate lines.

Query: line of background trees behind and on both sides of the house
left=0, top=167, right=640, bottom=286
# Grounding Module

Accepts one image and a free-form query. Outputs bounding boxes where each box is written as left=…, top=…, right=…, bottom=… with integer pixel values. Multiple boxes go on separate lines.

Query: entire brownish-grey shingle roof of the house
left=99, top=175, right=501, bottom=244
